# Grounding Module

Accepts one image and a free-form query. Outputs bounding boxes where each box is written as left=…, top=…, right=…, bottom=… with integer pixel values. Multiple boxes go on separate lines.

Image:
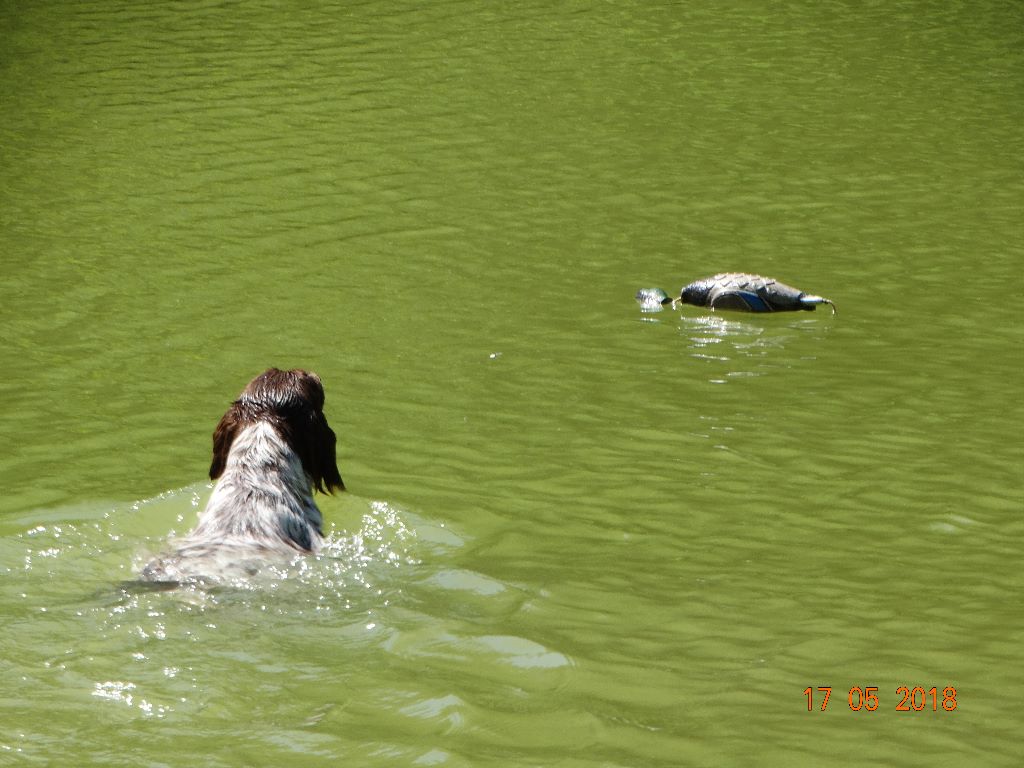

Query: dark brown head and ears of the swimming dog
left=210, top=368, right=345, bottom=494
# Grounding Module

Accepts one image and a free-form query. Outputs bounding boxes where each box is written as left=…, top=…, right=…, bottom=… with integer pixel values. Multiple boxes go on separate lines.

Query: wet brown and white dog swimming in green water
left=140, top=368, right=345, bottom=583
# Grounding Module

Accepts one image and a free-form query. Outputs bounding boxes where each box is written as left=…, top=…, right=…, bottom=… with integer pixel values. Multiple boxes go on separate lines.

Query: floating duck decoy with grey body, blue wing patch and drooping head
left=637, top=272, right=836, bottom=314
